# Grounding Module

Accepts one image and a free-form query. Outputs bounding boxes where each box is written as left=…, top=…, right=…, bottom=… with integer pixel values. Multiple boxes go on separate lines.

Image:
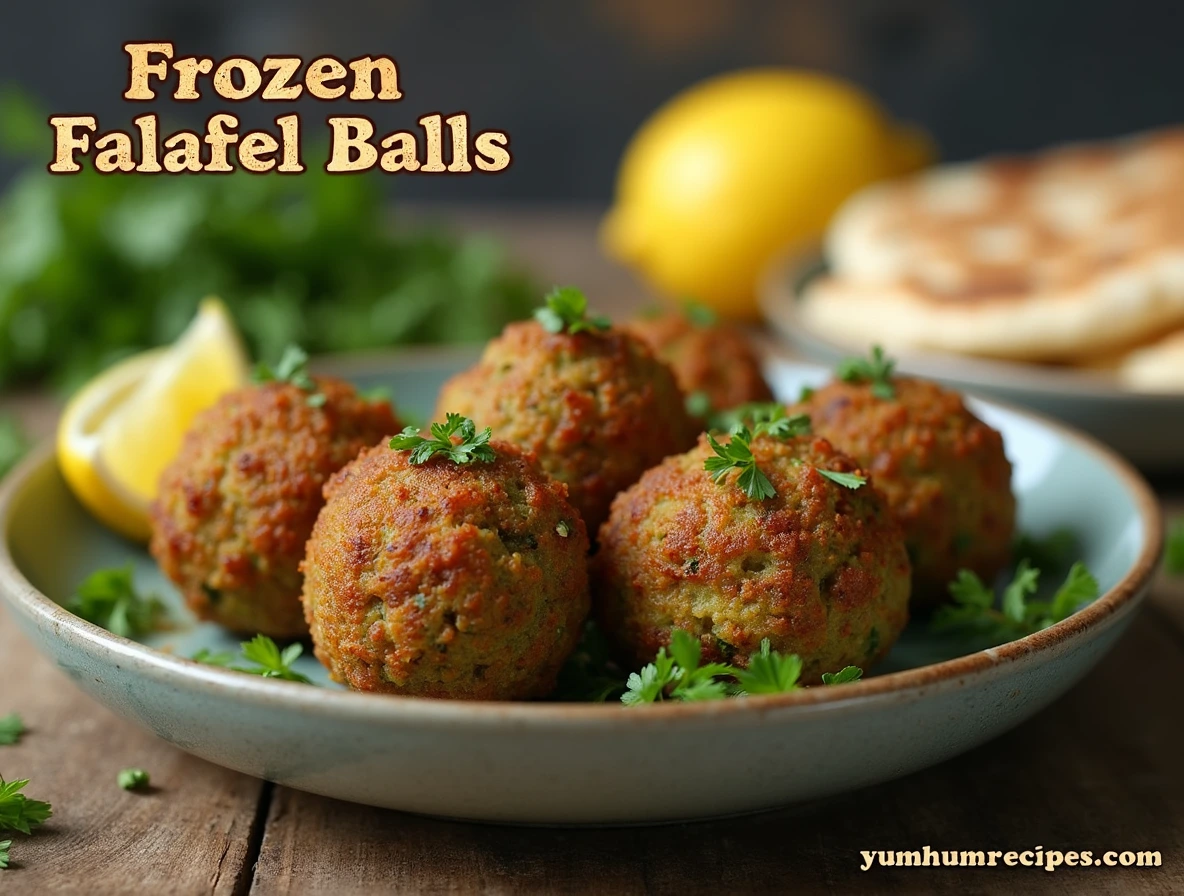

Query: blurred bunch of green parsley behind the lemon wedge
left=0, top=91, right=539, bottom=389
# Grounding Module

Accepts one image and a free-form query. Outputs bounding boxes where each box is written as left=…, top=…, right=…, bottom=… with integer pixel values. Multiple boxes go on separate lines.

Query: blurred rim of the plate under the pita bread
left=758, top=245, right=1184, bottom=397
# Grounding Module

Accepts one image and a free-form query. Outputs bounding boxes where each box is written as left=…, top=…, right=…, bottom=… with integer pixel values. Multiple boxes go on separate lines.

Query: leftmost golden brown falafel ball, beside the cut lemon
left=150, top=378, right=400, bottom=639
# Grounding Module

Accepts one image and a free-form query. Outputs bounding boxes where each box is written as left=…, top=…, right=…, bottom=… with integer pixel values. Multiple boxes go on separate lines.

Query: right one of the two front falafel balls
left=593, top=436, right=909, bottom=684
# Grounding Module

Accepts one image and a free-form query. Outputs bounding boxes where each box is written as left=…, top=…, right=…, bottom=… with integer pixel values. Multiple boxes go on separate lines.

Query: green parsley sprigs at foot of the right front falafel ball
left=620, top=629, right=863, bottom=707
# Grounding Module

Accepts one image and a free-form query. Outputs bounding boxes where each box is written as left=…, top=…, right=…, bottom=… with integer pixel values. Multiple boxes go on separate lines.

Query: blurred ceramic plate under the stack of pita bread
left=761, top=254, right=1184, bottom=471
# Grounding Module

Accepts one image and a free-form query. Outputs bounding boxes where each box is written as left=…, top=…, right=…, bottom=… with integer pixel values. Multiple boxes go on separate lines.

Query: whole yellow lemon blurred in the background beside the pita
left=601, top=69, right=933, bottom=318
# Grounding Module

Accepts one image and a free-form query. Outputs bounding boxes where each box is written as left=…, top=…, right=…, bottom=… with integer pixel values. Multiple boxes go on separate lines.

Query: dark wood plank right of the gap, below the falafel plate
left=252, top=610, right=1184, bottom=896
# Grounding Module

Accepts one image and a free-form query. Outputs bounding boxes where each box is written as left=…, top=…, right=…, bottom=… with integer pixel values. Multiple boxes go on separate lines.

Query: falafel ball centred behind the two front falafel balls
left=436, top=322, right=700, bottom=533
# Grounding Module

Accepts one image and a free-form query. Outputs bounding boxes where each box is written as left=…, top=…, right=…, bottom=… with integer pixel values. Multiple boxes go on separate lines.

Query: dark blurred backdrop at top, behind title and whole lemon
left=0, top=0, right=1184, bottom=201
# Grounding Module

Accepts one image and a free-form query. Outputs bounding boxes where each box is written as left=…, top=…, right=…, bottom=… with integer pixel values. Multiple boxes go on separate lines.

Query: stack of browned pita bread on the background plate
left=802, top=128, right=1184, bottom=392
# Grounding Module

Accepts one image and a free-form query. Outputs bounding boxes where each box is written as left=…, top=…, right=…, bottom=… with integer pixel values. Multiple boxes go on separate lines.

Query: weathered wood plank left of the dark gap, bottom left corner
left=0, top=596, right=263, bottom=896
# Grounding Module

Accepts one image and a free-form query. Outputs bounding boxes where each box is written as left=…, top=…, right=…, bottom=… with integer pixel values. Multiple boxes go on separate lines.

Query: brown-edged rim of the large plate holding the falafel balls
left=0, top=371, right=1164, bottom=727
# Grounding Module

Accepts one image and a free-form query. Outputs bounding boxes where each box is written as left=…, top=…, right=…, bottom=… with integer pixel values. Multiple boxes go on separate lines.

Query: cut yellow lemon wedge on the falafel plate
left=57, top=298, right=247, bottom=541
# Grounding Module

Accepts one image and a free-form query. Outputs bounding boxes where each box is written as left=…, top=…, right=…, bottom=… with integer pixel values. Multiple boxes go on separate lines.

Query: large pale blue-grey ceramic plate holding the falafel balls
left=0, top=355, right=1162, bottom=824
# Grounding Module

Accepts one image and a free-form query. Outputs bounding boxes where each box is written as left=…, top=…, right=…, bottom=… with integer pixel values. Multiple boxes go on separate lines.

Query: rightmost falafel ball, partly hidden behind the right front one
left=794, top=376, right=1016, bottom=608
